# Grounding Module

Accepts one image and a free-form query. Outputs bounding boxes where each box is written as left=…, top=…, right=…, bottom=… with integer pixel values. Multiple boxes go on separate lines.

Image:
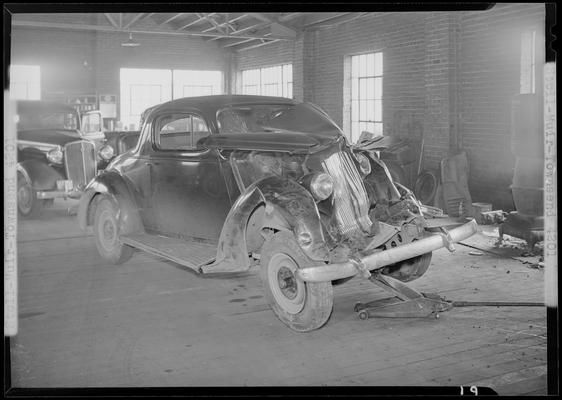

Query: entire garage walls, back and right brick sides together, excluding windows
left=11, top=3, right=545, bottom=211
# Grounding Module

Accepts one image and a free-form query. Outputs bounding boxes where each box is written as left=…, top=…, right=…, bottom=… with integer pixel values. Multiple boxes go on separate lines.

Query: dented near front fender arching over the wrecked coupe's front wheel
left=202, top=176, right=328, bottom=272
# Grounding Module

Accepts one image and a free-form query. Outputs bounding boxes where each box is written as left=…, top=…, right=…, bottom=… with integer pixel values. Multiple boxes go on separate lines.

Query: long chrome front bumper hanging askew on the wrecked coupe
left=297, top=219, right=478, bottom=282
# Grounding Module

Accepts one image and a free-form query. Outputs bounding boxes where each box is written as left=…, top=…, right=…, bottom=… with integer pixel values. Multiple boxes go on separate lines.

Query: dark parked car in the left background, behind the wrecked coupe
left=16, top=100, right=108, bottom=218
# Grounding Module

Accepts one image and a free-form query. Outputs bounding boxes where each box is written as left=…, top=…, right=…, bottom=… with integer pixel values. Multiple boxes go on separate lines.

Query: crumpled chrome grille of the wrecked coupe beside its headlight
left=322, top=152, right=372, bottom=236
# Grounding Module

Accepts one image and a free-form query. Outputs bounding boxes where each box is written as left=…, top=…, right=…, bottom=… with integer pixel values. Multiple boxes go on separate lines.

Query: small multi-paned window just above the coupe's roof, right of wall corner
left=242, top=64, right=293, bottom=98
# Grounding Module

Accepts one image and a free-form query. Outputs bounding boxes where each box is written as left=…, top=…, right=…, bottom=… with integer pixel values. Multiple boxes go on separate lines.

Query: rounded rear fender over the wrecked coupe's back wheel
left=78, top=171, right=144, bottom=233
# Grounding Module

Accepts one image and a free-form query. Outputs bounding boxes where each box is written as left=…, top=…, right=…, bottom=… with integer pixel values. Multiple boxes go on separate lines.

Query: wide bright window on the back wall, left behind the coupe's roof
left=120, top=68, right=223, bottom=129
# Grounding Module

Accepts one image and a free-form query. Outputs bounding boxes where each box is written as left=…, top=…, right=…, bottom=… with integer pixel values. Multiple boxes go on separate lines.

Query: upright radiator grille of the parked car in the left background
left=64, top=140, right=96, bottom=188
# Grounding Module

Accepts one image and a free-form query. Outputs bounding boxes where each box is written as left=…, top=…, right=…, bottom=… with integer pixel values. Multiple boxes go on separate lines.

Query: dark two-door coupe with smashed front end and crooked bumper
left=78, top=95, right=476, bottom=332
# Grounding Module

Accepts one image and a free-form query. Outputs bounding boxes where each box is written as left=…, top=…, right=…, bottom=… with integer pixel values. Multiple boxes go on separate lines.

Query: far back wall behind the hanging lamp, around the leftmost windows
left=11, top=27, right=230, bottom=117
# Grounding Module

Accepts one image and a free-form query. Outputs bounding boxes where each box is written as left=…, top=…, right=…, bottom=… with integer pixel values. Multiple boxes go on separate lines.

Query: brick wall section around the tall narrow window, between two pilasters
left=304, top=13, right=425, bottom=137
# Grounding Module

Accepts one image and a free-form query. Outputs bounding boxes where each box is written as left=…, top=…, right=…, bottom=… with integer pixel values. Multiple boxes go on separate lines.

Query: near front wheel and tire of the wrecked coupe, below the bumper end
left=260, top=232, right=333, bottom=332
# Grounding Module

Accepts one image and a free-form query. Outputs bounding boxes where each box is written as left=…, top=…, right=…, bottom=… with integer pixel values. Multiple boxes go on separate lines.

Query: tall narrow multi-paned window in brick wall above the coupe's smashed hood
left=351, top=52, right=383, bottom=142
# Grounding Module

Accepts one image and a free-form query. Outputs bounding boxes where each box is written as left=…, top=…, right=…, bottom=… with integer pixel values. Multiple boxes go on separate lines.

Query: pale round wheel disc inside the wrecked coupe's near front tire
left=267, top=253, right=306, bottom=314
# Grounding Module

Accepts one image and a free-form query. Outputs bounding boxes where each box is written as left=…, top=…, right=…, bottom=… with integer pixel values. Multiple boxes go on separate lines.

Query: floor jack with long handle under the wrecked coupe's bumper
left=354, top=272, right=545, bottom=320
